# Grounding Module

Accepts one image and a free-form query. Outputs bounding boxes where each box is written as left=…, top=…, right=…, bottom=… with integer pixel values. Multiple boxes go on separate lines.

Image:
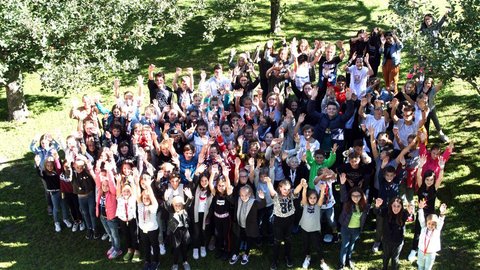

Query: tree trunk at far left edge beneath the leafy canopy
left=5, top=71, right=29, bottom=122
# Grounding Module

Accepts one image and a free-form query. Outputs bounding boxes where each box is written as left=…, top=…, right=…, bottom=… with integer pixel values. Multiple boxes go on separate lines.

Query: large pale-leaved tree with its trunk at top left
left=0, top=0, right=253, bottom=121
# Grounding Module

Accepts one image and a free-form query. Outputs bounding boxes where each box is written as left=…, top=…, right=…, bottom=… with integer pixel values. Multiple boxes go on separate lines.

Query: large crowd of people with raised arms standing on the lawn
left=31, top=12, right=453, bottom=270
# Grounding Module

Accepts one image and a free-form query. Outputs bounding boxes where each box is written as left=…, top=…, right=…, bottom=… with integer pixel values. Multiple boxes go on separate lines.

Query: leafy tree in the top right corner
left=385, top=0, right=480, bottom=94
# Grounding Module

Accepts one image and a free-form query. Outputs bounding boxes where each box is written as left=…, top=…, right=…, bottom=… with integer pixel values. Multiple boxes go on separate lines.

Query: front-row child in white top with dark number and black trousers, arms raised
left=265, top=177, right=302, bottom=270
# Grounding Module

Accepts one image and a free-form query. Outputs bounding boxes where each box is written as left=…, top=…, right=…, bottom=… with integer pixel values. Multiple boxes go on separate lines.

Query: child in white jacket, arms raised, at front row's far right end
left=417, top=200, right=447, bottom=270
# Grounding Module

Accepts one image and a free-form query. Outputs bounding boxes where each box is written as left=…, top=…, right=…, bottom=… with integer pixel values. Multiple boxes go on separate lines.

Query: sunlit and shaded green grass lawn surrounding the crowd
left=0, top=0, right=480, bottom=269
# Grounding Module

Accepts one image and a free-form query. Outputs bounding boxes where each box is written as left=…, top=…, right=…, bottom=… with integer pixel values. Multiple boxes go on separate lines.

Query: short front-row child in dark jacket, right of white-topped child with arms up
left=165, top=188, right=193, bottom=270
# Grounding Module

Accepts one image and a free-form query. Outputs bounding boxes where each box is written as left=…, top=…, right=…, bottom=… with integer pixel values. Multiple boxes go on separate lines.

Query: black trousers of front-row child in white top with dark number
left=273, top=215, right=294, bottom=263
